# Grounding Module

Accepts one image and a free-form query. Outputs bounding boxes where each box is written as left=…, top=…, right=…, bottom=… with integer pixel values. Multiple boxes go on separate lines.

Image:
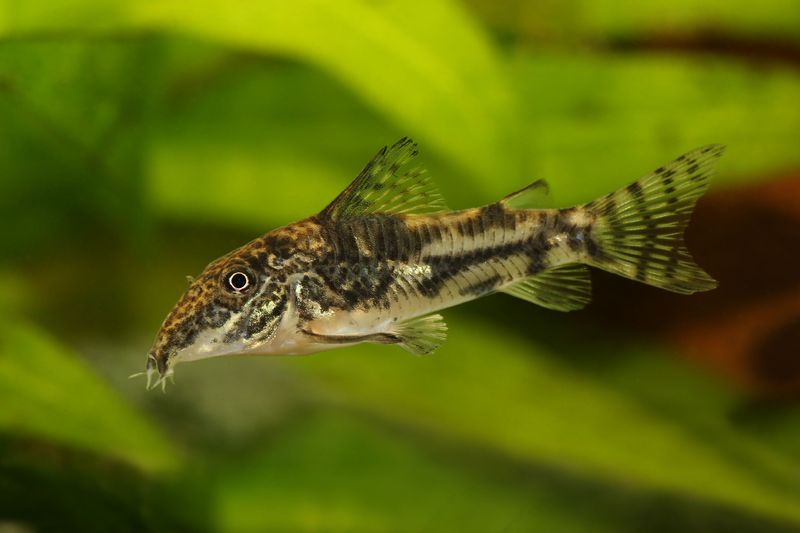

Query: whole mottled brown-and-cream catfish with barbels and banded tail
left=140, top=138, right=725, bottom=388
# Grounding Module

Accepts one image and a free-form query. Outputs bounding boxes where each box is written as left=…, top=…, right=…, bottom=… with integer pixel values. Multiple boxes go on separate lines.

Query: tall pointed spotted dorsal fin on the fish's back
left=320, top=137, right=447, bottom=219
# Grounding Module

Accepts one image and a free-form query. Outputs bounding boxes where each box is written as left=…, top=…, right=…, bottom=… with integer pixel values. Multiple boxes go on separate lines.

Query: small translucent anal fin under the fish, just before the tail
left=501, top=263, right=592, bottom=311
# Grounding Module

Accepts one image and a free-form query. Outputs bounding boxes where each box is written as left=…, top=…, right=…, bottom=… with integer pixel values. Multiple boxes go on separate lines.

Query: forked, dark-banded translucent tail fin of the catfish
left=586, top=144, right=725, bottom=294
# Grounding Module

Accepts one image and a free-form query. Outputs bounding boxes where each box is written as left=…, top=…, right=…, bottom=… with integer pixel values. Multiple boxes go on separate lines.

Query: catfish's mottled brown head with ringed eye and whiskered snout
left=146, top=248, right=288, bottom=386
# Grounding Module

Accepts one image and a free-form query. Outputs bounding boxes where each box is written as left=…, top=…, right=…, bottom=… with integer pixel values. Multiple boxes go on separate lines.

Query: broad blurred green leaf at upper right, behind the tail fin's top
left=513, top=54, right=800, bottom=205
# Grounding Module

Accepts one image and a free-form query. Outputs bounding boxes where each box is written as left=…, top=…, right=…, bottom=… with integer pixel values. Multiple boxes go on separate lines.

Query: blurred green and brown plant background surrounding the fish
left=0, top=0, right=800, bottom=532
